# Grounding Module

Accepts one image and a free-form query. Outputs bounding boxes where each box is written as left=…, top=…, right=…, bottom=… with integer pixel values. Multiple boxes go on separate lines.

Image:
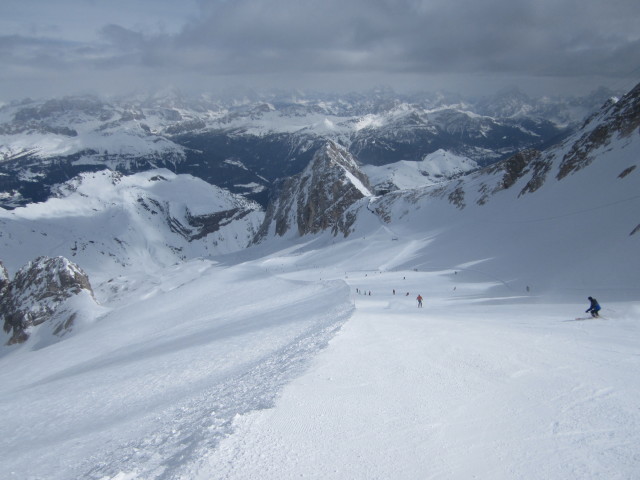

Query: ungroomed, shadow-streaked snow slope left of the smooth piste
left=0, top=261, right=353, bottom=479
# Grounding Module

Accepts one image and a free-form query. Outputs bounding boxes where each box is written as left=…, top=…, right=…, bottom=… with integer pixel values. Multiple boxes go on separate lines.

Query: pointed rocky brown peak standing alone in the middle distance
left=256, top=142, right=371, bottom=242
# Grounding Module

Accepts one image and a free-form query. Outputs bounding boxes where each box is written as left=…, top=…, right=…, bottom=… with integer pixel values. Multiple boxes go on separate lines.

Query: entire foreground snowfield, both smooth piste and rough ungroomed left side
left=0, top=229, right=640, bottom=480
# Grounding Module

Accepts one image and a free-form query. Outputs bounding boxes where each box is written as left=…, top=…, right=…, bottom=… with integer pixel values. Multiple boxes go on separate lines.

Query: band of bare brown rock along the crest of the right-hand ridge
left=368, top=85, right=640, bottom=229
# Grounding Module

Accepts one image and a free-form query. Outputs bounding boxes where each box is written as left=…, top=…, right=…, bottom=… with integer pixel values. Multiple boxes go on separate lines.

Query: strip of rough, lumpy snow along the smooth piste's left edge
left=73, top=281, right=355, bottom=480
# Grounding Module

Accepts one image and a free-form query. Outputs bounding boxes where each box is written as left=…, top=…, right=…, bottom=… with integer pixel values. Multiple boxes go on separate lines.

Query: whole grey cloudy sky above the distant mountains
left=0, top=0, right=640, bottom=101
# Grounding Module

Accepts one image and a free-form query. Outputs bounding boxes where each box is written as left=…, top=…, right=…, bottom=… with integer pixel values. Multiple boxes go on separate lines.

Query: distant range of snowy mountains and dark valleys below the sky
left=0, top=91, right=608, bottom=208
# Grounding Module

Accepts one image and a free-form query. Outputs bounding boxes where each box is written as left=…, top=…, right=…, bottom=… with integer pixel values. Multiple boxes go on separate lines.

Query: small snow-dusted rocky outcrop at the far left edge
left=0, top=257, right=93, bottom=345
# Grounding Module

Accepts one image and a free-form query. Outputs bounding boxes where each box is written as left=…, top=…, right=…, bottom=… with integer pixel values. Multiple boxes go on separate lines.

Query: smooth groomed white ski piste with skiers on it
left=195, top=262, right=640, bottom=480
